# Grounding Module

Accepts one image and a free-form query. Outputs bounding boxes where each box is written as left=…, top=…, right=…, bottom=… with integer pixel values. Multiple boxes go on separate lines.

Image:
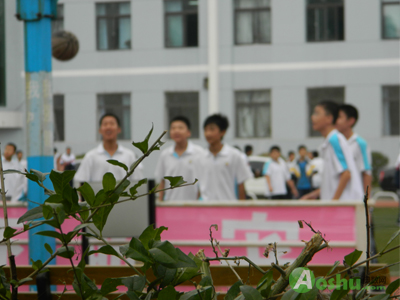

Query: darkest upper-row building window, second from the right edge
left=307, top=0, right=344, bottom=42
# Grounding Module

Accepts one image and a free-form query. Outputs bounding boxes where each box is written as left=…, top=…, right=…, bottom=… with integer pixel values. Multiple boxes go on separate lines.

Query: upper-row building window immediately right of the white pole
left=234, top=0, right=271, bottom=45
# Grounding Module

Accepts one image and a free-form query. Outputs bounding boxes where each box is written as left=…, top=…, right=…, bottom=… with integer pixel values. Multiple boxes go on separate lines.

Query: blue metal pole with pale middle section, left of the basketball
left=17, top=0, right=57, bottom=278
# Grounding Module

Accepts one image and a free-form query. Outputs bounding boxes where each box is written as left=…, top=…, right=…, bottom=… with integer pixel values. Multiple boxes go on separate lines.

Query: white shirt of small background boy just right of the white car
left=262, top=158, right=291, bottom=196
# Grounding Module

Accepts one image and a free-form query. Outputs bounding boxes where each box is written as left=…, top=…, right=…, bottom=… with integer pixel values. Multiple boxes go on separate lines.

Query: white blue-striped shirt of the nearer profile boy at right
left=320, top=129, right=363, bottom=201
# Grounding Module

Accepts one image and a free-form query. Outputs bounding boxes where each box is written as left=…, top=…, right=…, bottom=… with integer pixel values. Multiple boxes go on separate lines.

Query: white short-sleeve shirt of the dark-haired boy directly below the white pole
left=196, top=144, right=253, bottom=201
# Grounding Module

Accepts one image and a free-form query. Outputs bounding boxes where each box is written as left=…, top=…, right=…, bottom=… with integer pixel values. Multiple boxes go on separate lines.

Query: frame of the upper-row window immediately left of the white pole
left=163, top=0, right=200, bottom=49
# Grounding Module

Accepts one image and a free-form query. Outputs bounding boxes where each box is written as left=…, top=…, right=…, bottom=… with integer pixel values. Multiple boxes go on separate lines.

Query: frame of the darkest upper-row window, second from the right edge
left=306, top=0, right=346, bottom=43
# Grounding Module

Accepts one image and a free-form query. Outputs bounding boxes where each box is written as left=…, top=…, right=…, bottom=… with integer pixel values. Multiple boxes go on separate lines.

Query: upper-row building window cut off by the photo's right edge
left=382, top=0, right=400, bottom=39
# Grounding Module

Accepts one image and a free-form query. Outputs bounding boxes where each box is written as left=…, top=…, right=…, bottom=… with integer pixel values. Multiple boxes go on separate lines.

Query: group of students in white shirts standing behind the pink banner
left=3, top=101, right=371, bottom=201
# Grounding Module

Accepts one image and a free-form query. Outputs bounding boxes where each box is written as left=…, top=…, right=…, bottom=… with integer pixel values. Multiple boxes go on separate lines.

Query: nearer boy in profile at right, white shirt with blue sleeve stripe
left=301, top=101, right=363, bottom=201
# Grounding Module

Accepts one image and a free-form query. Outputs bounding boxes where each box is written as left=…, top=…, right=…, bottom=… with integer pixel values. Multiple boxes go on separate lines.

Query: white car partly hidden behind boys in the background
left=244, top=156, right=271, bottom=199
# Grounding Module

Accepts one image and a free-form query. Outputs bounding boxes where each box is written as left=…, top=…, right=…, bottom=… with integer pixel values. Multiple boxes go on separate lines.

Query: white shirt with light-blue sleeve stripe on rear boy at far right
left=348, top=133, right=371, bottom=175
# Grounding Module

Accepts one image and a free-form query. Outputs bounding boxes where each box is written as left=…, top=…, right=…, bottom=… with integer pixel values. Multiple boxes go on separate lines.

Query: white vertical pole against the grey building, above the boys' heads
left=208, top=0, right=219, bottom=114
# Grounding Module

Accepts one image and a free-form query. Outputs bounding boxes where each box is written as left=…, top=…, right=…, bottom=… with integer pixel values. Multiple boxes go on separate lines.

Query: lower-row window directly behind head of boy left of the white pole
left=165, top=92, right=199, bottom=138
